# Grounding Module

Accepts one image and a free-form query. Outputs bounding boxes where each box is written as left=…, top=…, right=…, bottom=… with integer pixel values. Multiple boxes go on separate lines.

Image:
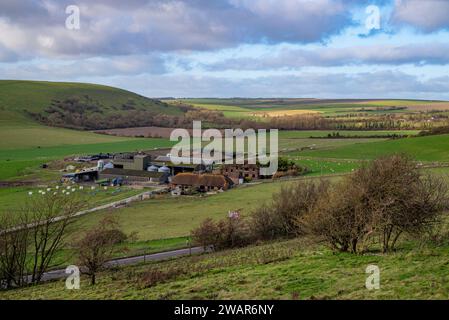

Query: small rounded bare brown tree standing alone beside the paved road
left=75, top=217, right=126, bottom=285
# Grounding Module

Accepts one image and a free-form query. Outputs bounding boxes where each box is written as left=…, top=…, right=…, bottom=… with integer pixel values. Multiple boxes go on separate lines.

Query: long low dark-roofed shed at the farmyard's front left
left=99, top=168, right=169, bottom=183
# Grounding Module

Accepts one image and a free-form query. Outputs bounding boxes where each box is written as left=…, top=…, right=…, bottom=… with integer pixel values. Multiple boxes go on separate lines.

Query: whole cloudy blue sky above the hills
left=0, top=0, right=449, bottom=100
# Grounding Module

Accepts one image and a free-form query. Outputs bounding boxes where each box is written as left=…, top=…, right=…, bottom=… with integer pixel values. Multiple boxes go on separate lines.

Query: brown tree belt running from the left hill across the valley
left=28, top=96, right=448, bottom=131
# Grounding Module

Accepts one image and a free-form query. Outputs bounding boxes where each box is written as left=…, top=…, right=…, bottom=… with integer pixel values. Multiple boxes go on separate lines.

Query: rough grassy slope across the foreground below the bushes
left=0, top=236, right=449, bottom=299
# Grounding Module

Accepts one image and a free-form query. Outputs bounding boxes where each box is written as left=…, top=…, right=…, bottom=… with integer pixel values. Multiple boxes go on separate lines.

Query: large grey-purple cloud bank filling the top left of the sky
left=0, top=0, right=351, bottom=59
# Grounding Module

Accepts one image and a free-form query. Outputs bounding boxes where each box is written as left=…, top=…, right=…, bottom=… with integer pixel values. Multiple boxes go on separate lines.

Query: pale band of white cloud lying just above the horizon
left=97, top=71, right=449, bottom=99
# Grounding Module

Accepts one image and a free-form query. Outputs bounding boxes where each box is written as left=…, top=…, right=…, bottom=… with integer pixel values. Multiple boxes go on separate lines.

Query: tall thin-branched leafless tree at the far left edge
left=0, top=193, right=85, bottom=288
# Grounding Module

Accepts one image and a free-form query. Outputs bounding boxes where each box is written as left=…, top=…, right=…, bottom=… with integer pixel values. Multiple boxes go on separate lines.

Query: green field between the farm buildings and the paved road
left=68, top=182, right=306, bottom=240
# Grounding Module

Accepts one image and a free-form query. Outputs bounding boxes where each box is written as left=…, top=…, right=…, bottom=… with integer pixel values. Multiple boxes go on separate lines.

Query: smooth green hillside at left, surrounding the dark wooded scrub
left=0, top=80, right=182, bottom=180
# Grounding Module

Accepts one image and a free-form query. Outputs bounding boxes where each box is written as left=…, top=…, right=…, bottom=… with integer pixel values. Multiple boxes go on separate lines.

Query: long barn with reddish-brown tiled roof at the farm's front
left=171, top=173, right=234, bottom=192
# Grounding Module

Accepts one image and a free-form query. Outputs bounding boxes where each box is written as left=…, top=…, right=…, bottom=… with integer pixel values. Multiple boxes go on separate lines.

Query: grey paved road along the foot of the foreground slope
left=42, top=247, right=209, bottom=281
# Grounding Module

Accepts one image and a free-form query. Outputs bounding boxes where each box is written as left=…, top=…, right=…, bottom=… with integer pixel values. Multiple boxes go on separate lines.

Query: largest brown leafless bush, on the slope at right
left=301, top=155, right=448, bottom=252
